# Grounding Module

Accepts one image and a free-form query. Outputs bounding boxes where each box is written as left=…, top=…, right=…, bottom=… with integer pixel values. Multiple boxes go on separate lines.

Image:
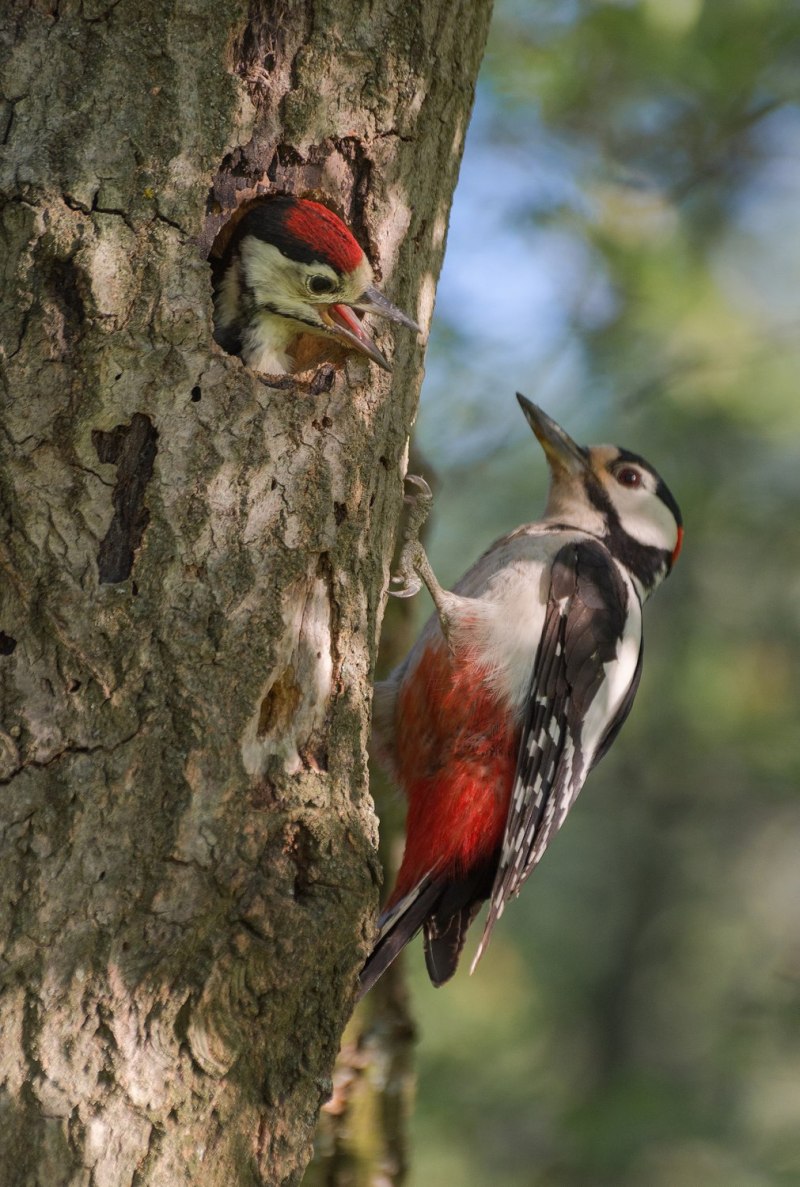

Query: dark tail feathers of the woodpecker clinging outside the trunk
left=358, top=858, right=497, bottom=998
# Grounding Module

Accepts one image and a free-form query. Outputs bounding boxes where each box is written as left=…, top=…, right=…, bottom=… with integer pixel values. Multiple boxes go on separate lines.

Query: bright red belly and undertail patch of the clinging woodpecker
left=387, top=646, right=520, bottom=906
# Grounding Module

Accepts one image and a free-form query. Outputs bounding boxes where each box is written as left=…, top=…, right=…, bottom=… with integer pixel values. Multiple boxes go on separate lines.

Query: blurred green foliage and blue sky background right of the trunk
left=391, top=0, right=800, bottom=1187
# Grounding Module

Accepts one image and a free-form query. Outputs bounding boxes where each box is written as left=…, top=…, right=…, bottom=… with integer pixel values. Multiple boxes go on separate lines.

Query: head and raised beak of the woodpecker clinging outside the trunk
left=518, top=393, right=684, bottom=596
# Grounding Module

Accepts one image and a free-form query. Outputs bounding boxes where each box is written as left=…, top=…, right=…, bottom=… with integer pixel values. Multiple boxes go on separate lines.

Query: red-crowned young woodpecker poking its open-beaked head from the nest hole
left=214, top=196, right=419, bottom=375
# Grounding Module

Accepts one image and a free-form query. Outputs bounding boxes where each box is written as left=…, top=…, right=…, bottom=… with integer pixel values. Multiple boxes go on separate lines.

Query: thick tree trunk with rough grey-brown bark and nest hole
left=0, top=0, right=489, bottom=1187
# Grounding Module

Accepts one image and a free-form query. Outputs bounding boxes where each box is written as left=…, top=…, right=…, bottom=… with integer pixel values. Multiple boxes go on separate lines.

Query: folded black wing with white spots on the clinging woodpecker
left=472, top=540, right=641, bottom=969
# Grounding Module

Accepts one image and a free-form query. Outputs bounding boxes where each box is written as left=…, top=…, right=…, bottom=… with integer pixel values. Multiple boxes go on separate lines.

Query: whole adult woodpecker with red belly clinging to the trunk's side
left=361, top=395, right=682, bottom=992
